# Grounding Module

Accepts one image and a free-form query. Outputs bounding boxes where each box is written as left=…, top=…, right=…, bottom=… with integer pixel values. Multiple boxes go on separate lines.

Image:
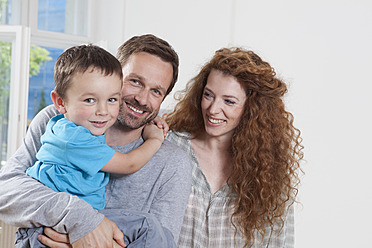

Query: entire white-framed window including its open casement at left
left=0, top=0, right=94, bottom=167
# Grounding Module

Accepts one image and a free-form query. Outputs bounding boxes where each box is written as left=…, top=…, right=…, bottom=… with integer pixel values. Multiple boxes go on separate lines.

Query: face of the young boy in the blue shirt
left=64, top=69, right=122, bottom=135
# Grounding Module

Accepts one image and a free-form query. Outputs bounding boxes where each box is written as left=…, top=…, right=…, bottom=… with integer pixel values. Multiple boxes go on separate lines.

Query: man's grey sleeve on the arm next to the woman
left=151, top=141, right=191, bottom=242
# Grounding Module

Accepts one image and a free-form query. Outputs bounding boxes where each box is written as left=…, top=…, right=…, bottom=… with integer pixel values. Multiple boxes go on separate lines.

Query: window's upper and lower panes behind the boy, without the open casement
left=27, top=0, right=92, bottom=122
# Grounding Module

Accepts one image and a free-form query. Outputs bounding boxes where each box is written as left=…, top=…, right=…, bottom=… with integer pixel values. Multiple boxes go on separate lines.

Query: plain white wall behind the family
left=98, top=0, right=372, bottom=248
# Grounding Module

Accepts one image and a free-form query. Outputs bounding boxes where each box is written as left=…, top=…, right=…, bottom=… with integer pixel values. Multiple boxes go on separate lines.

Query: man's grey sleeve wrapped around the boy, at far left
left=0, top=106, right=104, bottom=242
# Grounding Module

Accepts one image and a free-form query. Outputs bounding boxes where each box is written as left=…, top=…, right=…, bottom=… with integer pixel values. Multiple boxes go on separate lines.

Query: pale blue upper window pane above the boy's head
left=37, top=0, right=88, bottom=36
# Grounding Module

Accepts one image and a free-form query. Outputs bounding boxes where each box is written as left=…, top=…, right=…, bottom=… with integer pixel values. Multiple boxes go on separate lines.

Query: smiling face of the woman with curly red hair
left=201, top=69, right=247, bottom=138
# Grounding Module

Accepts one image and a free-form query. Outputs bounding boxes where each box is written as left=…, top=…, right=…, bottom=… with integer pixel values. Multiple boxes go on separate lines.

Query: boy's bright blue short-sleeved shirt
left=27, top=114, right=115, bottom=210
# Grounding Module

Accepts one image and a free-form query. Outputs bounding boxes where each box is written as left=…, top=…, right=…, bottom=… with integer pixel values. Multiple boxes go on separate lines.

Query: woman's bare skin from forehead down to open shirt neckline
left=191, top=70, right=246, bottom=193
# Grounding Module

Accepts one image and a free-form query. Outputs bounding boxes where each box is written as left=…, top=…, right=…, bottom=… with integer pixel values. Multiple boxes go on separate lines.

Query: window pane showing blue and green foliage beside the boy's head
left=27, top=45, right=63, bottom=122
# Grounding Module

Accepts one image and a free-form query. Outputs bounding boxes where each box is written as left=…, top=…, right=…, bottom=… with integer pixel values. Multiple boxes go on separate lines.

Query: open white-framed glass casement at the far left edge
left=0, top=25, right=30, bottom=166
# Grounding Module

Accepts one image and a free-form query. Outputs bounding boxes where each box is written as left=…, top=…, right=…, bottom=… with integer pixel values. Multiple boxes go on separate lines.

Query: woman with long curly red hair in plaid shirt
left=167, top=48, right=303, bottom=248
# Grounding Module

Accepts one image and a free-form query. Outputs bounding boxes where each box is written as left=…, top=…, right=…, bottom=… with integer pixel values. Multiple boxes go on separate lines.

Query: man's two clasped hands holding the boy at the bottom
left=39, top=217, right=126, bottom=248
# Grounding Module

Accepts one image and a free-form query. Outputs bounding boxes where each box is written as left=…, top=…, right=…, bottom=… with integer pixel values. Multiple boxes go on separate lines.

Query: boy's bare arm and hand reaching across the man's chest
left=101, top=124, right=164, bottom=174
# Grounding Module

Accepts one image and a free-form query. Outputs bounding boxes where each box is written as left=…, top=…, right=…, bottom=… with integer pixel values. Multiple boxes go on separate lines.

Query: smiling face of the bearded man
left=118, top=52, right=173, bottom=129
